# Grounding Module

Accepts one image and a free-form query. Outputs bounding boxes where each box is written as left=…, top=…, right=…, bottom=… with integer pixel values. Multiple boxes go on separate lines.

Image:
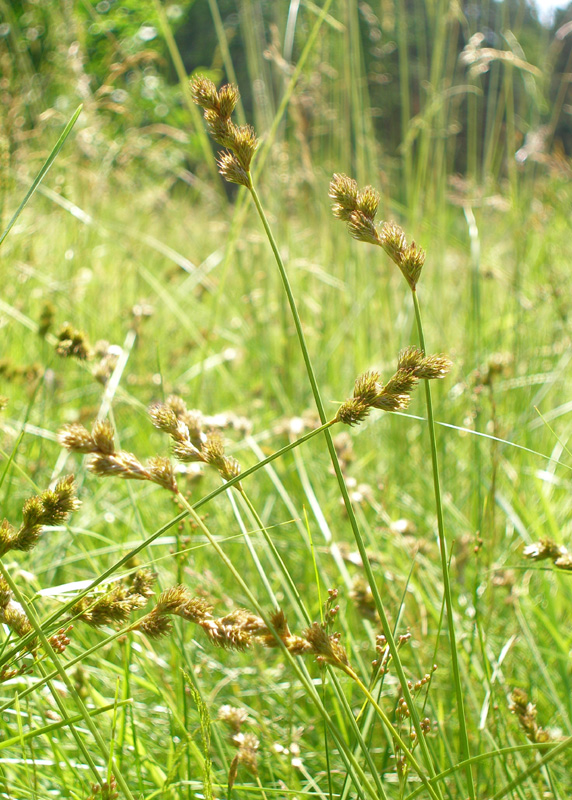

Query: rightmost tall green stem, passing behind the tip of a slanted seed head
left=411, top=289, right=476, bottom=800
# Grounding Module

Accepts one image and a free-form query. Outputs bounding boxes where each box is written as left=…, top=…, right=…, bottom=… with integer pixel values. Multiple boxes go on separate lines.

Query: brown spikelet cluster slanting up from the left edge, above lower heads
left=0, top=475, right=80, bottom=556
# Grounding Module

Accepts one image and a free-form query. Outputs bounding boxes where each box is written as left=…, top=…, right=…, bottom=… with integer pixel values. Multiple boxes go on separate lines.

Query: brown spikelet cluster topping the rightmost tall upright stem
left=329, top=174, right=425, bottom=290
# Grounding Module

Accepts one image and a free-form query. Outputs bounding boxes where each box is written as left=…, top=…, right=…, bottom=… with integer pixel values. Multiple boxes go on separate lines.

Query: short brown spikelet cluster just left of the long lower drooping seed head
left=71, top=569, right=155, bottom=628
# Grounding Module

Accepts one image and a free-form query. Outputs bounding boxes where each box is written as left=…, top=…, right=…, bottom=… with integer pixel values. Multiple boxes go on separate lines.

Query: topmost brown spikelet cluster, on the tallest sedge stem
left=190, top=76, right=258, bottom=189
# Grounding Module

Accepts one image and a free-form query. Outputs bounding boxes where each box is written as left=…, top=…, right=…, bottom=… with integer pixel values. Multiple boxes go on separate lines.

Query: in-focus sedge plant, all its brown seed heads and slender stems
left=0, top=73, right=482, bottom=800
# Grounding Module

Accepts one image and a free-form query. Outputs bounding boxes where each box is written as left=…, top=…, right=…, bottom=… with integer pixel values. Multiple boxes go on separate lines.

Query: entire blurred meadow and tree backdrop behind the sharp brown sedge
left=0, top=0, right=572, bottom=800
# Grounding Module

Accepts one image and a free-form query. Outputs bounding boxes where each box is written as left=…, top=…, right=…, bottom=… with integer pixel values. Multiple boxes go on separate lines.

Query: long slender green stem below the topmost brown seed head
left=250, top=178, right=440, bottom=791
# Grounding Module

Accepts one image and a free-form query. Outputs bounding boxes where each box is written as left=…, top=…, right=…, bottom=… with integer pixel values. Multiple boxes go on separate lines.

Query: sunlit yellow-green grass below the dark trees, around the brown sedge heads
left=0, top=3, right=572, bottom=800
